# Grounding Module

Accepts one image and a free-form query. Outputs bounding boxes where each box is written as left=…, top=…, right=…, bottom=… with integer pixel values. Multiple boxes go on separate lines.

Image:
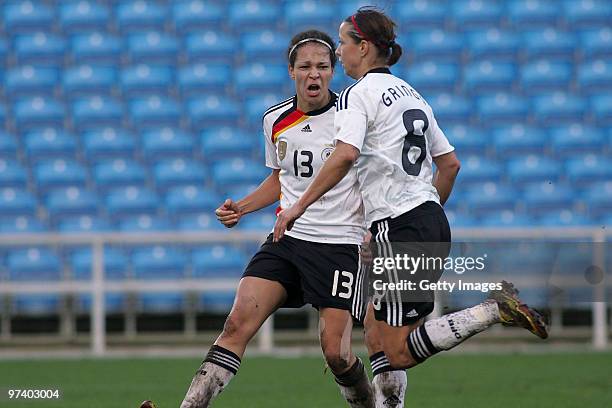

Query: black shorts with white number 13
left=242, top=234, right=366, bottom=320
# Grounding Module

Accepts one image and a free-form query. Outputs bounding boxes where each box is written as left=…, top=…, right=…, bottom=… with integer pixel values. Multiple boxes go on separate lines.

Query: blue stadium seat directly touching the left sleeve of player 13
left=200, top=126, right=256, bottom=163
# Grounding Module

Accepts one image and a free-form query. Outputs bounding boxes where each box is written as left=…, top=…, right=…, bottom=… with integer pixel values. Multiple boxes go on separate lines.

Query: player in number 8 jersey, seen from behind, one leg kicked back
left=274, top=7, right=548, bottom=402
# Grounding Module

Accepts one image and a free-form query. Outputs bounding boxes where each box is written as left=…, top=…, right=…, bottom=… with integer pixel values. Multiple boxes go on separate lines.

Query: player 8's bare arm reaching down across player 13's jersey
left=274, top=141, right=359, bottom=242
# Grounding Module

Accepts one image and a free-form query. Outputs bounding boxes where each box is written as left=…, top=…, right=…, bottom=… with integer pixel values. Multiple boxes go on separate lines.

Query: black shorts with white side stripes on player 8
left=370, top=201, right=451, bottom=327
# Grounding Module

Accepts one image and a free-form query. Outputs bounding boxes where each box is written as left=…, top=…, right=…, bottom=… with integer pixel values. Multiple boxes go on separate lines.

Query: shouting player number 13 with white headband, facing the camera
left=181, top=30, right=388, bottom=408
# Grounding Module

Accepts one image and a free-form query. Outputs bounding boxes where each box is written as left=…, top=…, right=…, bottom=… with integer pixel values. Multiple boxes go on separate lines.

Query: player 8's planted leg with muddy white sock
left=363, top=303, right=408, bottom=408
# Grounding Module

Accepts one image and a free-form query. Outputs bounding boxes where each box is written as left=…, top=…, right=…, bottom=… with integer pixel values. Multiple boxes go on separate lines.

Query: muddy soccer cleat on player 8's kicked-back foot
left=489, top=281, right=548, bottom=339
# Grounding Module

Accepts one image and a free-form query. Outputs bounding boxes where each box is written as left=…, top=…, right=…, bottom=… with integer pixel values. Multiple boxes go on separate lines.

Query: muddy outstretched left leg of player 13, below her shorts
left=181, top=276, right=287, bottom=408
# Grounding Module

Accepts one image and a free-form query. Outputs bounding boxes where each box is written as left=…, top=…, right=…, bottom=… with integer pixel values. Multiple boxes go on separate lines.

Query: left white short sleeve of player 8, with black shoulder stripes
left=334, top=87, right=368, bottom=151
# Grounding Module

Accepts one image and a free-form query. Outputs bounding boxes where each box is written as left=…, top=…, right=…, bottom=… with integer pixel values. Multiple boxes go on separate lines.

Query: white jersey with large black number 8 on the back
left=335, top=68, right=454, bottom=226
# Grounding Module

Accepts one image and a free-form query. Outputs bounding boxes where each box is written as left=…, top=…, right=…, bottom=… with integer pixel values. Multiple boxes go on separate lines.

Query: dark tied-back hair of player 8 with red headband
left=344, top=6, right=402, bottom=65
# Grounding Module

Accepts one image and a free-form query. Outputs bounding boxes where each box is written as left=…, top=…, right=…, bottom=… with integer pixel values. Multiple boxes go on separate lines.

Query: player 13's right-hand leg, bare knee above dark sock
left=319, top=307, right=374, bottom=408
